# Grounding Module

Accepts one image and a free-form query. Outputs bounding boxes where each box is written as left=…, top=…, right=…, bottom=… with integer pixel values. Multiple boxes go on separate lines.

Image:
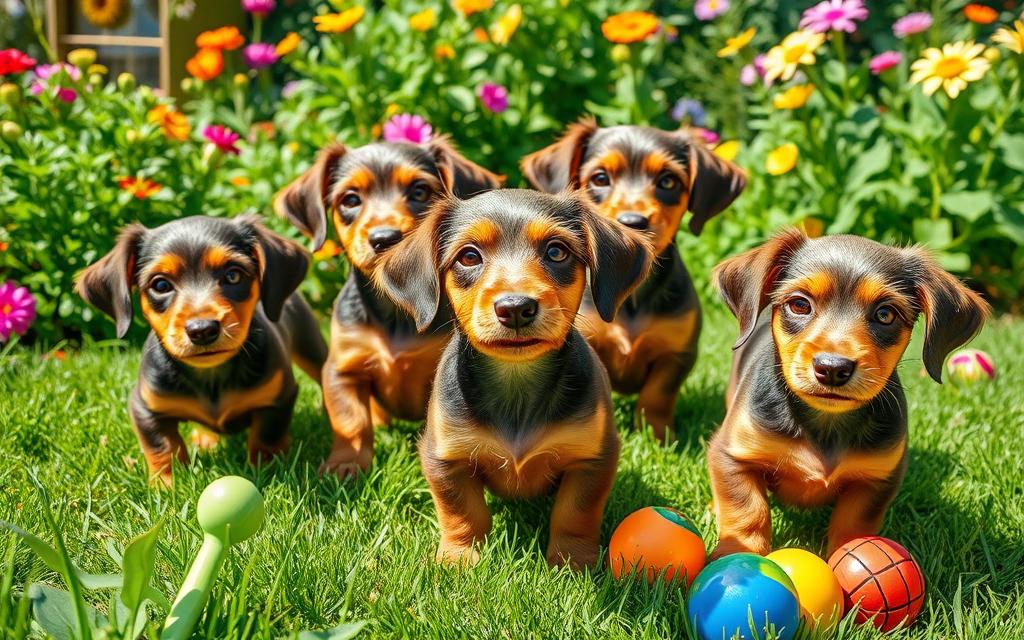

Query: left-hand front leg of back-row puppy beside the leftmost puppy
left=319, top=359, right=374, bottom=479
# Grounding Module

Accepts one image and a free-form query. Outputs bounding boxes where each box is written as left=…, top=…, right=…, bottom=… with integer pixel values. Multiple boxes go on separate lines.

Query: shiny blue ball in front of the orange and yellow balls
left=686, top=553, right=800, bottom=640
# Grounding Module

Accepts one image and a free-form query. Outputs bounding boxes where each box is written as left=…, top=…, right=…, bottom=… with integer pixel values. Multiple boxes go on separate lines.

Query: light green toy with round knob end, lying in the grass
left=160, top=475, right=264, bottom=640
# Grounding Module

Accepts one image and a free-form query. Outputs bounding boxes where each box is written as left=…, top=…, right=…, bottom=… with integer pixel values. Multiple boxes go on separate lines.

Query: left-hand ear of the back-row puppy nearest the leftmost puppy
left=273, top=142, right=346, bottom=251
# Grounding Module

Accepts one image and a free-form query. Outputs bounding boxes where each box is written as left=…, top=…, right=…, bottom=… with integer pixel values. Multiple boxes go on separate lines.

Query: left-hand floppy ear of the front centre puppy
left=373, top=197, right=446, bottom=333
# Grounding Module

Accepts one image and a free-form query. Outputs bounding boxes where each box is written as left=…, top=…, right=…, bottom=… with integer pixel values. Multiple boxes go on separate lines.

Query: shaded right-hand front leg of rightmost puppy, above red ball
left=828, top=456, right=906, bottom=556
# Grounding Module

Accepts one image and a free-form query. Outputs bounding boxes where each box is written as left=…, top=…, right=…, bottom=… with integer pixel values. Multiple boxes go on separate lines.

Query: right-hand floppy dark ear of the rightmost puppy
left=905, top=247, right=991, bottom=384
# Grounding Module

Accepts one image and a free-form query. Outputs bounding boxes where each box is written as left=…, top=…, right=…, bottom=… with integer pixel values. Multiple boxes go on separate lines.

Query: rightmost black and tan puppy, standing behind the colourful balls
left=708, top=230, right=989, bottom=556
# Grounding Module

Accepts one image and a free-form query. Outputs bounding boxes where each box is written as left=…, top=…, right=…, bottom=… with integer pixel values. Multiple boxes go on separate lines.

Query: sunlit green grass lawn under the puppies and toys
left=0, top=304, right=1024, bottom=638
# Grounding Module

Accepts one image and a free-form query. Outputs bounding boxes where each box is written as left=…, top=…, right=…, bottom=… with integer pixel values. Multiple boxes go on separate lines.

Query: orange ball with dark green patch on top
left=608, top=507, right=708, bottom=585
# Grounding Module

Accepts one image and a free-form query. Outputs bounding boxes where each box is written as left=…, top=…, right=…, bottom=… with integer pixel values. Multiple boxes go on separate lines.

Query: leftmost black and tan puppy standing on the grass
left=78, top=216, right=327, bottom=483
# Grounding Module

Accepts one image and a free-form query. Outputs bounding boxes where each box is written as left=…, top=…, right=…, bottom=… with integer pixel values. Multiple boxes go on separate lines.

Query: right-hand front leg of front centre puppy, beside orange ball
left=547, top=446, right=618, bottom=569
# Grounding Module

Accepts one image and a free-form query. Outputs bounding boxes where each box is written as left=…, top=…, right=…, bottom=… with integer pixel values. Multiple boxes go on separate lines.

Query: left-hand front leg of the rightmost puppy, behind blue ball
left=708, top=431, right=771, bottom=559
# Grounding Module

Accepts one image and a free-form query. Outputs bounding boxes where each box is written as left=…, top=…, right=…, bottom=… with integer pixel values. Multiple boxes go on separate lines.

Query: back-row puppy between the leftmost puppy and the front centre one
left=274, top=138, right=501, bottom=477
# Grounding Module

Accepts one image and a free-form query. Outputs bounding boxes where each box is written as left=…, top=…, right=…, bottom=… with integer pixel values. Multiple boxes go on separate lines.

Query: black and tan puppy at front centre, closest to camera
left=379, top=189, right=650, bottom=566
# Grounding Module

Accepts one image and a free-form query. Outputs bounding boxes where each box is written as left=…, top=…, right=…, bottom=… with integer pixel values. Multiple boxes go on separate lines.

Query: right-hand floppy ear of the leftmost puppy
left=236, top=215, right=309, bottom=323
